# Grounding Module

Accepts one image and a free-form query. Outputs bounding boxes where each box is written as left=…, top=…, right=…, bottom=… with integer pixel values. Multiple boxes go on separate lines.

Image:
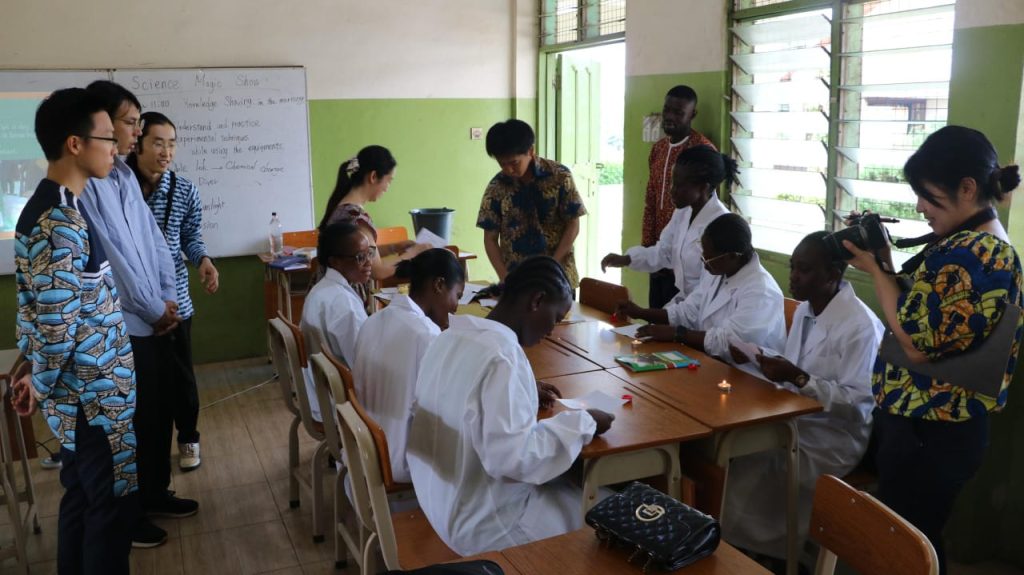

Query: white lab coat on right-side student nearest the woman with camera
left=722, top=281, right=883, bottom=558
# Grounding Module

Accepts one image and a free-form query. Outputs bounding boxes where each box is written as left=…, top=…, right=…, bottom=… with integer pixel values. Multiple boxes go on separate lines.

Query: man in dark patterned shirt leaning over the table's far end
left=476, top=120, right=587, bottom=290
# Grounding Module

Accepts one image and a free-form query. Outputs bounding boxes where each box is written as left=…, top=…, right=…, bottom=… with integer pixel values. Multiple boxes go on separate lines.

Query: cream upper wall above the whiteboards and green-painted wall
left=0, top=0, right=539, bottom=99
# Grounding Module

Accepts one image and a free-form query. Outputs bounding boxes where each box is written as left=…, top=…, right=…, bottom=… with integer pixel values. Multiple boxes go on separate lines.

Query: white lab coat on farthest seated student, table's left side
left=299, top=268, right=367, bottom=422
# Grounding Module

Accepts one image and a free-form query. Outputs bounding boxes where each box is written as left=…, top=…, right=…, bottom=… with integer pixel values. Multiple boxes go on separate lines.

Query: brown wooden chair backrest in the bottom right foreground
left=810, top=475, right=939, bottom=575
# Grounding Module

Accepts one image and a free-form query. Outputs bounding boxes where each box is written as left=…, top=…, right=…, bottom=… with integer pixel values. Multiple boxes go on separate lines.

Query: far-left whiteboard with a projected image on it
left=0, top=70, right=110, bottom=273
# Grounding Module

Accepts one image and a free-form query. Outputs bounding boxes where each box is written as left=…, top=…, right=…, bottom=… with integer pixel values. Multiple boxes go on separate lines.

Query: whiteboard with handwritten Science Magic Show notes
left=113, top=68, right=313, bottom=257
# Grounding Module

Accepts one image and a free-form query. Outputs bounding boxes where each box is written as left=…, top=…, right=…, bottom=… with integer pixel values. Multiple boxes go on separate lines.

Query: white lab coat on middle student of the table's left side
left=352, top=295, right=441, bottom=483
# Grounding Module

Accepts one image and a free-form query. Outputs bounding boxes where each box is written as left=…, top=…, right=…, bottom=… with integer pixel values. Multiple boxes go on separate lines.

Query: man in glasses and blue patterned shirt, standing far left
left=11, top=88, right=138, bottom=574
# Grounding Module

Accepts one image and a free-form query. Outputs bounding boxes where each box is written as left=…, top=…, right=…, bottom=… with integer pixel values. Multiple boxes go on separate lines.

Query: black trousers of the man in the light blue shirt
left=131, top=336, right=174, bottom=510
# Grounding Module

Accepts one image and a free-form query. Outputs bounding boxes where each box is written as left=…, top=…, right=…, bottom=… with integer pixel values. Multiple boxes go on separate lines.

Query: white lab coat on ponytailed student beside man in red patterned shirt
left=626, top=194, right=729, bottom=304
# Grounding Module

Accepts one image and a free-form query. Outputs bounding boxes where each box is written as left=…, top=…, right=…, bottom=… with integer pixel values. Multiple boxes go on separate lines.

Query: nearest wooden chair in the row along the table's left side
left=336, top=399, right=459, bottom=575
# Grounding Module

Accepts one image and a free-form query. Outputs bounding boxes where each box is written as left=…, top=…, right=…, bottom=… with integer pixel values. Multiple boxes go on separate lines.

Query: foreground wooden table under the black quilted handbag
left=502, top=528, right=771, bottom=575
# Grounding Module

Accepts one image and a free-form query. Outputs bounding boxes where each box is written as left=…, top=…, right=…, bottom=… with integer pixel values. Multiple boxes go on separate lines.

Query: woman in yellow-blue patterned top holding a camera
left=843, top=126, right=1022, bottom=573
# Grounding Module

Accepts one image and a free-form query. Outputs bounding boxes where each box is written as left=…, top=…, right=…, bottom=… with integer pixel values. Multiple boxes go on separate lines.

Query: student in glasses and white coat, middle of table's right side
left=615, top=214, right=785, bottom=358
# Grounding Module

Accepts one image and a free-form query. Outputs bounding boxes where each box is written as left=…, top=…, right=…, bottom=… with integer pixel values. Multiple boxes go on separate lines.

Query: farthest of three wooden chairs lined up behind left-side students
left=268, top=312, right=328, bottom=543
